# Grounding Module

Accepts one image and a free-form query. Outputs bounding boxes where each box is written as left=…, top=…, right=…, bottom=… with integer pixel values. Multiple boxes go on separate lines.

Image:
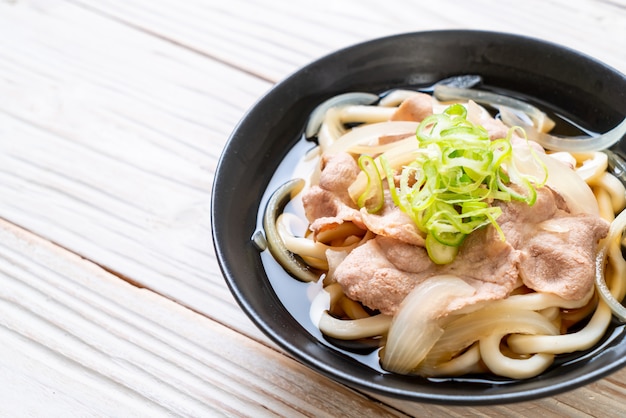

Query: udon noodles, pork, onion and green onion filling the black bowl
left=264, top=77, right=626, bottom=379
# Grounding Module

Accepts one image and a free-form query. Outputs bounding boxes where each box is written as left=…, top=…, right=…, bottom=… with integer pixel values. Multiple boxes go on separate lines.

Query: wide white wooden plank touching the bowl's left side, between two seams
left=0, top=1, right=269, bottom=337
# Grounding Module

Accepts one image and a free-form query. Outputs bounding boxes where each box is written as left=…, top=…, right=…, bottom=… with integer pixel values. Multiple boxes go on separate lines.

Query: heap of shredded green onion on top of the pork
left=372, top=104, right=547, bottom=264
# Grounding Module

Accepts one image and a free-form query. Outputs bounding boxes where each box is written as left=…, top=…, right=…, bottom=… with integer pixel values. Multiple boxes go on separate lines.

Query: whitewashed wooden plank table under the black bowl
left=0, top=0, right=626, bottom=417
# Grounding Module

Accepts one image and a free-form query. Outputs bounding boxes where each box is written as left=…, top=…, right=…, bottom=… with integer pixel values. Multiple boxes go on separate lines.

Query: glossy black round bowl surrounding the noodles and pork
left=212, top=31, right=626, bottom=405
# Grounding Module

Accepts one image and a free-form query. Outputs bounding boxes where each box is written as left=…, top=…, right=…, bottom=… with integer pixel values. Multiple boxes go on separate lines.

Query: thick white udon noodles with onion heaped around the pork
left=266, top=86, right=626, bottom=379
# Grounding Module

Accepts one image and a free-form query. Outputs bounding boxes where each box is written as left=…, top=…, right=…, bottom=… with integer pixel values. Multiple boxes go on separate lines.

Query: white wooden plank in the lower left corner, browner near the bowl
left=0, top=221, right=399, bottom=417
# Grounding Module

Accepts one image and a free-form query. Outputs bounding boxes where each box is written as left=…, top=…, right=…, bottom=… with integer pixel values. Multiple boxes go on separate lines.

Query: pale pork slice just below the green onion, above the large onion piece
left=334, top=231, right=518, bottom=315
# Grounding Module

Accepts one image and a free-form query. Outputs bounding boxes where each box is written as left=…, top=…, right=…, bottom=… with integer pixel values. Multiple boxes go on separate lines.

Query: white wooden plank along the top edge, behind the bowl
left=68, top=0, right=626, bottom=81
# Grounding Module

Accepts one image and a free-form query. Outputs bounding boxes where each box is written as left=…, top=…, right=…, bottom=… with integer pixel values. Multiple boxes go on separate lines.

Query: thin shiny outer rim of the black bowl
left=211, top=29, right=626, bottom=405
